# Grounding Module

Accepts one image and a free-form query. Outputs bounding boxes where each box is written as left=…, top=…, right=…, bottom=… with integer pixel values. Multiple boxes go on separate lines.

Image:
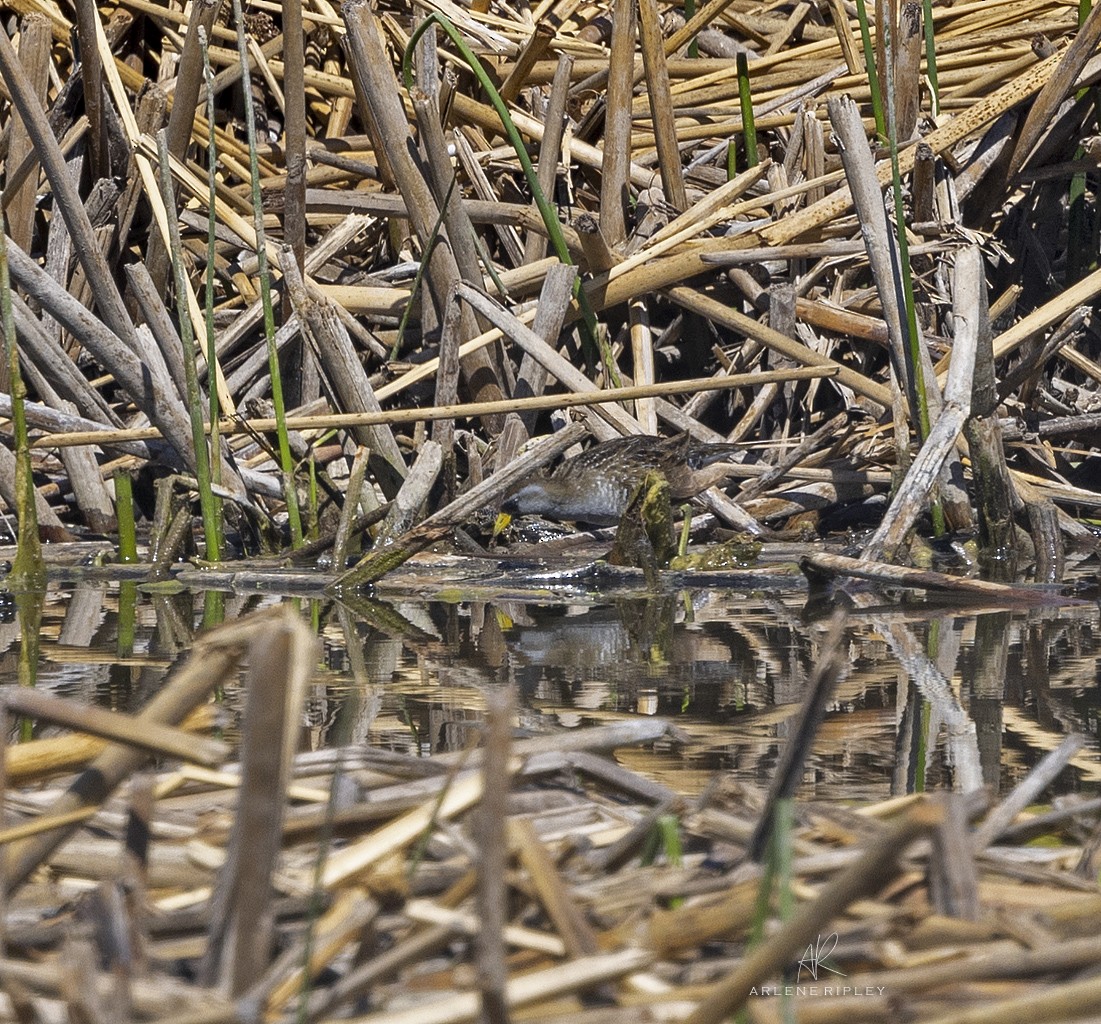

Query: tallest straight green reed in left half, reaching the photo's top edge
left=233, top=0, right=302, bottom=547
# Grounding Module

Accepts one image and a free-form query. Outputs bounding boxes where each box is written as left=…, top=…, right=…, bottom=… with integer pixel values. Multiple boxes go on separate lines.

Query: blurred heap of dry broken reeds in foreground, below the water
left=0, top=606, right=1101, bottom=1024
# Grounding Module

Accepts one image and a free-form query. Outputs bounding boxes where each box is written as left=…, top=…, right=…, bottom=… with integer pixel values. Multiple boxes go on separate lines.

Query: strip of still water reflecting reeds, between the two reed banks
left=0, top=584, right=1101, bottom=800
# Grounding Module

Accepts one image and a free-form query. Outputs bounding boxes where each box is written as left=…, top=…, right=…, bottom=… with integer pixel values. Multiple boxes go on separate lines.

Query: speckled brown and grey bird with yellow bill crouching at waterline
left=501, top=434, right=741, bottom=526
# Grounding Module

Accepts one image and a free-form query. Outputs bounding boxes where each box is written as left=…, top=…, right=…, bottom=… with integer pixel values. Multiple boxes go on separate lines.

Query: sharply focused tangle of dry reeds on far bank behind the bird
left=0, top=0, right=1101, bottom=586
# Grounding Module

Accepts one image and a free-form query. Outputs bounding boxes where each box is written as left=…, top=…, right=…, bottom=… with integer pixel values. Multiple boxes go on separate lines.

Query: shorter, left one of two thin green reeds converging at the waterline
left=156, top=128, right=221, bottom=562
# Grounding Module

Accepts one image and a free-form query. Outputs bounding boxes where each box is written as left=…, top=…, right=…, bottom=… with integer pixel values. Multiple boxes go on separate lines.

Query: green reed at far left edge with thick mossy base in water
left=0, top=203, right=45, bottom=589
